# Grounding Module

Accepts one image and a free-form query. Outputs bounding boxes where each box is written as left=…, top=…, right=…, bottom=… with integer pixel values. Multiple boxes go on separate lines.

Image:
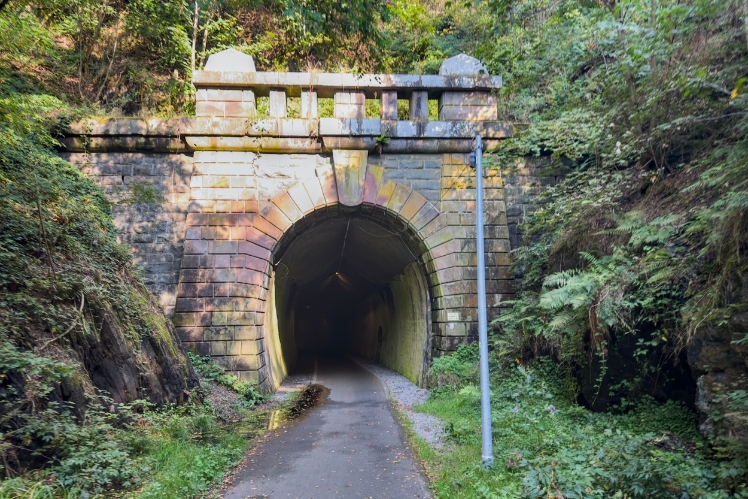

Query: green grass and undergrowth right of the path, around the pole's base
left=420, top=346, right=748, bottom=499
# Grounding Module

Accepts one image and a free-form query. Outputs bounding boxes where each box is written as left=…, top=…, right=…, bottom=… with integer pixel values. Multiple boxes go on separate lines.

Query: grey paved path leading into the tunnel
left=224, top=358, right=431, bottom=499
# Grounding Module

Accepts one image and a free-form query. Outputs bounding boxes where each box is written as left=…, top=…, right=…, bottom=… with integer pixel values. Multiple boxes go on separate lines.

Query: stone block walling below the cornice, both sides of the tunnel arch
left=65, top=151, right=525, bottom=383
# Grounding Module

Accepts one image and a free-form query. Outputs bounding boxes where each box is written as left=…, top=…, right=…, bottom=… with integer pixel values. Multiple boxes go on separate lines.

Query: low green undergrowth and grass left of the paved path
left=0, top=357, right=268, bottom=499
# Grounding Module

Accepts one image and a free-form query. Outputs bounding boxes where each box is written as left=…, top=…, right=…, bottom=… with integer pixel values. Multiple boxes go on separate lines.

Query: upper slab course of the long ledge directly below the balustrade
left=65, top=117, right=514, bottom=139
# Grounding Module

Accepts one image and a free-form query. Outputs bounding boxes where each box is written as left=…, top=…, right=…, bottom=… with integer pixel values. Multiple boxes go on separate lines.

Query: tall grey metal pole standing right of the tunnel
left=475, top=135, right=493, bottom=468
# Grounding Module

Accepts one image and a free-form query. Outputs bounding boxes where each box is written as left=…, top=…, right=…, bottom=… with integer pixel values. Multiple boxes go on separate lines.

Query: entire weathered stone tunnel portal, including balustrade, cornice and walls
left=63, top=51, right=524, bottom=389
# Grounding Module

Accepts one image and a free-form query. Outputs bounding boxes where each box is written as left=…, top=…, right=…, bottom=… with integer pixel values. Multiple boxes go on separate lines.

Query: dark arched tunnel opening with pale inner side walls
left=268, top=207, right=431, bottom=384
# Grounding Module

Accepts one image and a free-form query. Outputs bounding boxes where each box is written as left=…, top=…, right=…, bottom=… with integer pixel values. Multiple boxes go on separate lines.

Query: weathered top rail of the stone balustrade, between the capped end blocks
left=192, top=71, right=502, bottom=99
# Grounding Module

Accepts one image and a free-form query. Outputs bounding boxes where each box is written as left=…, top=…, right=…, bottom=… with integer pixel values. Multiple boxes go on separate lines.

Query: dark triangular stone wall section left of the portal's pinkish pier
left=62, top=153, right=192, bottom=317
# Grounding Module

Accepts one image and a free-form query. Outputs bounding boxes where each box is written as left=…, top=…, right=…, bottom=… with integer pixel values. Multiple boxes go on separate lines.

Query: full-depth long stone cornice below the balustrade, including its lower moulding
left=60, top=117, right=514, bottom=153
